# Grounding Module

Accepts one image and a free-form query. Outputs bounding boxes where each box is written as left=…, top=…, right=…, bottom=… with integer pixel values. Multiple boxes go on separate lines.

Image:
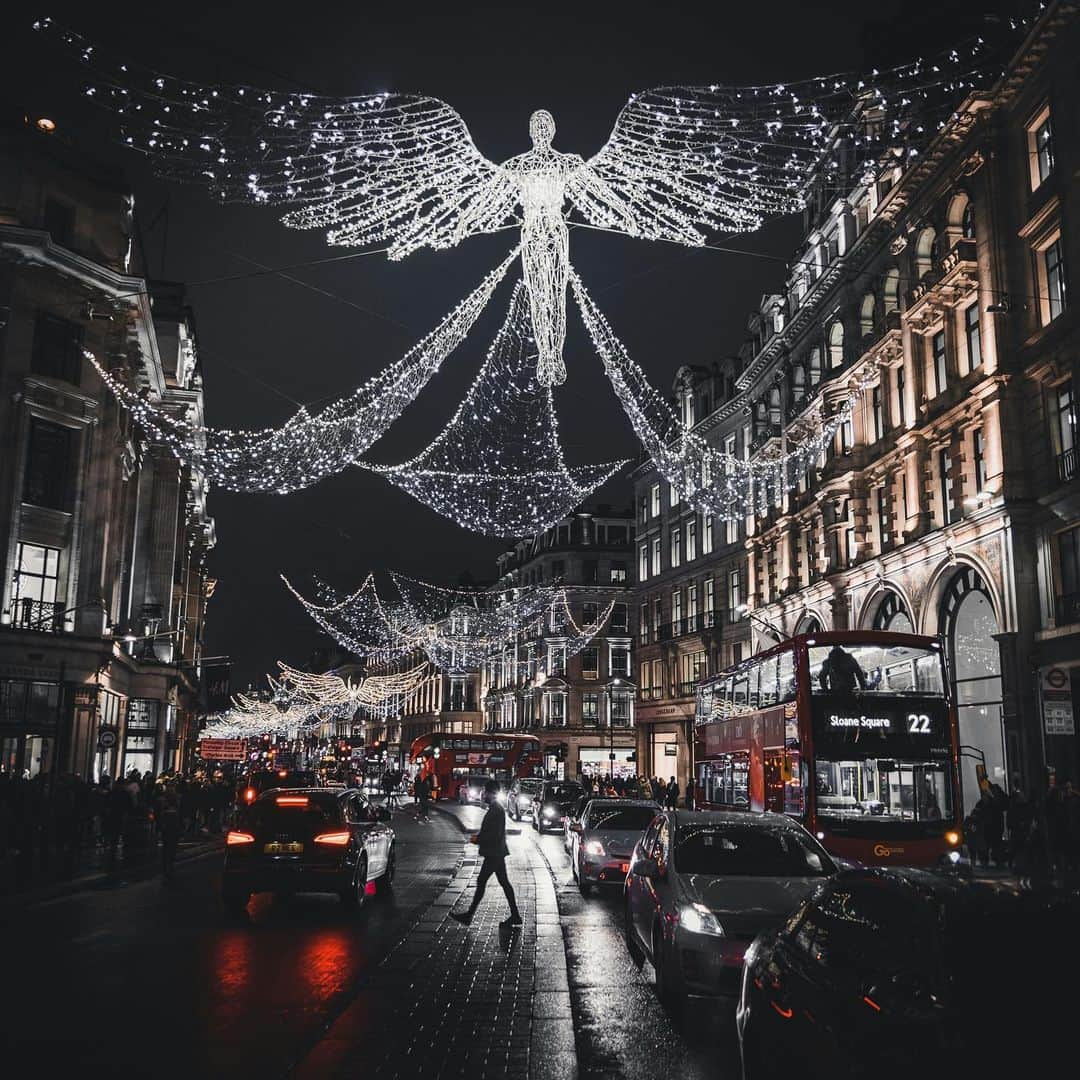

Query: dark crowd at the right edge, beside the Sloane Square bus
left=963, top=777, right=1080, bottom=875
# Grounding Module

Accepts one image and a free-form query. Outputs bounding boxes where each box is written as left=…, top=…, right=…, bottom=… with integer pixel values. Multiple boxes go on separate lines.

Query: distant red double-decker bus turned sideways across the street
left=409, top=731, right=543, bottom=799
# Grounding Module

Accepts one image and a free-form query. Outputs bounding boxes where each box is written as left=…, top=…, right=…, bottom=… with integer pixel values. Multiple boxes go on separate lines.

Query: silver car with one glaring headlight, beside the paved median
left=625, top=810, right=838, bottom=1015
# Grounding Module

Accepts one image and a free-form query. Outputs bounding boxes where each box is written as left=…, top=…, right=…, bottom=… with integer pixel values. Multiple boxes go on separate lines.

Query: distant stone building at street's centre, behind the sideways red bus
left=483, top=508, right=638, bottom=778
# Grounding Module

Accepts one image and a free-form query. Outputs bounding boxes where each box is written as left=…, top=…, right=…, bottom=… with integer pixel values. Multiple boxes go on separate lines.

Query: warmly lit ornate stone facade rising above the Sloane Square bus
left=635, top=3, right=1080, bottom=808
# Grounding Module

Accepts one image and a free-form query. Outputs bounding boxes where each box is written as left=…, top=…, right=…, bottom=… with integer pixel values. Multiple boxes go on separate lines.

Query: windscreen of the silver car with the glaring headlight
left=675, top=824, right=835, bottom=877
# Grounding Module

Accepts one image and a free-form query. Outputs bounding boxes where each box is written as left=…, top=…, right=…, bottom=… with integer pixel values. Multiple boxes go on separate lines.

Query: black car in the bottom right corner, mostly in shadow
left=735, top=868, right=1080, bottom=1080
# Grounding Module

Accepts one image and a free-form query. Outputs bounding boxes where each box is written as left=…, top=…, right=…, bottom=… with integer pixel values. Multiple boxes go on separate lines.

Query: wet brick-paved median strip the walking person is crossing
left=294, top=804, right=578, bottom=1080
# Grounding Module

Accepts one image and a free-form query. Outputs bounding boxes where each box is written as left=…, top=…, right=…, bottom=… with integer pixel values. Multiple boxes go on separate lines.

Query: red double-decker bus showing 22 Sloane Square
left=694, top=631, right=962, bottom=865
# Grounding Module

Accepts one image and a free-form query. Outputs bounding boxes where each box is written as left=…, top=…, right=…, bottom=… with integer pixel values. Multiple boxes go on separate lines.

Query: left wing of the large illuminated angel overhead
left=35, top=19, right=515, bottom=259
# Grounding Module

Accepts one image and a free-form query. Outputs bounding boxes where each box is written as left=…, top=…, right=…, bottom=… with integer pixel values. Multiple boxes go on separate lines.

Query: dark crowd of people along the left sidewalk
left=0, top=769, right=233, bottom=888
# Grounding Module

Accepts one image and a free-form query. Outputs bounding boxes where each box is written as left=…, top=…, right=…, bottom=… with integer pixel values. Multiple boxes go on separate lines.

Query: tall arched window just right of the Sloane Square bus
left=941, top=566, right=1008, bottom=813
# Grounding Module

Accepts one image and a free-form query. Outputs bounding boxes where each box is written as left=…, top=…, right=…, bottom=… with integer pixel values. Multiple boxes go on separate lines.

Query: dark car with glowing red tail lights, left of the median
left=221, top=787, right=395, bottom=915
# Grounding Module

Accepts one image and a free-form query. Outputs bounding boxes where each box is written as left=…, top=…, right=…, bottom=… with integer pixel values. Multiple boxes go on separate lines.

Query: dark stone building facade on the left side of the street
left=0, top=120, right=215, bottom=778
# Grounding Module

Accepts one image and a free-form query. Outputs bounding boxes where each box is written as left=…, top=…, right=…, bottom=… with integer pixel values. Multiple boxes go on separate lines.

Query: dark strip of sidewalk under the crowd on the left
left=0, top=833, right=225, bottom=906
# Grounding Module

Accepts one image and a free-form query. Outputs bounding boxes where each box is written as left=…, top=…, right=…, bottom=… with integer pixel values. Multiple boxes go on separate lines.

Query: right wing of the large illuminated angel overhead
left=583, top=41, right=985, bottom=245
